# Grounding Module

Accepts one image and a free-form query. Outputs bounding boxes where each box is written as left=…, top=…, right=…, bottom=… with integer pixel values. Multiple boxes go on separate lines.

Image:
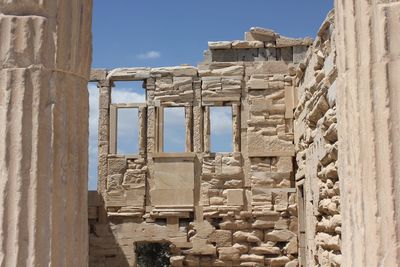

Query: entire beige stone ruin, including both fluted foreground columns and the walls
left=0, top=0, right=400, bottom=267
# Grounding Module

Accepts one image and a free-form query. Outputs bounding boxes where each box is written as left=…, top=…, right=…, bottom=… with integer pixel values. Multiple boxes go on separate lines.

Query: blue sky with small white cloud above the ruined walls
left=89, top=0, right=333, bottom=190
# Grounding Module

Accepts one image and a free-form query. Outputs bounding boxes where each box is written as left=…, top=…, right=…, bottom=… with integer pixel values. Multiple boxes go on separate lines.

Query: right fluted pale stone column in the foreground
left=335, top=0, right=400, bottom=266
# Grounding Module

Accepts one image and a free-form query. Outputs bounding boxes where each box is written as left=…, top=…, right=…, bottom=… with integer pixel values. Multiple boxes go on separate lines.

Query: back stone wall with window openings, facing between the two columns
left=89, top=28, right=312, bottom=266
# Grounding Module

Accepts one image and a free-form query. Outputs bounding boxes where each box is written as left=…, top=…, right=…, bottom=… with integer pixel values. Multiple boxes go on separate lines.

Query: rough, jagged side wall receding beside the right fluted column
left=294, top=12, right=341, bottom=266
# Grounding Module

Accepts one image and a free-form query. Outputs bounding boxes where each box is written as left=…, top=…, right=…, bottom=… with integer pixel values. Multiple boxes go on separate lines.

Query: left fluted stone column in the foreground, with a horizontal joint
left=0, top=0, right=92, bottom=267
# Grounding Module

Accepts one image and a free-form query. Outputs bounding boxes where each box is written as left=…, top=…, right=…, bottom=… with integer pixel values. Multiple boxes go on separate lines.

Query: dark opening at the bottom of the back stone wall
left=135, top=242, right=170, bottom=267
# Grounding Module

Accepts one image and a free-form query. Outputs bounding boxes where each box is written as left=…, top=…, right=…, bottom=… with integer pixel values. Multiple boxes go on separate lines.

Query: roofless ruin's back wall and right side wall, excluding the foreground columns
left=89, top=13, right=341, bottom=267
